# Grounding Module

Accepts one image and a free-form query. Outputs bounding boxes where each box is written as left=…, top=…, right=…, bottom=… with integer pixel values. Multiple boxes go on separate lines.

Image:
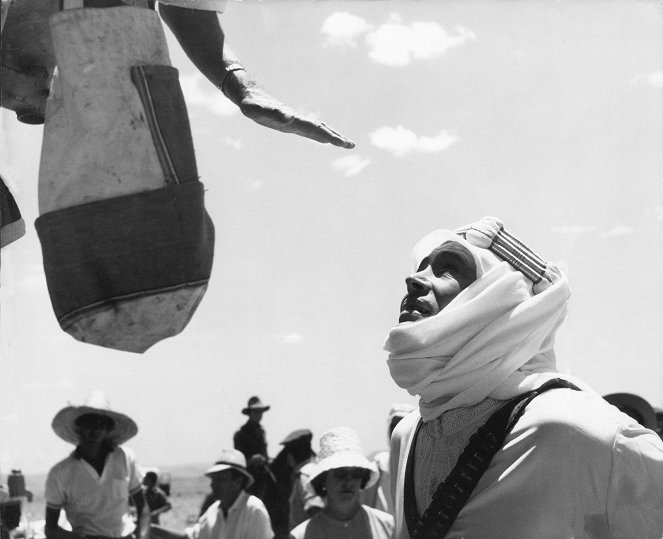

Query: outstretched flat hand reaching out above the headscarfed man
left=226, top=72, right=355, bottom=149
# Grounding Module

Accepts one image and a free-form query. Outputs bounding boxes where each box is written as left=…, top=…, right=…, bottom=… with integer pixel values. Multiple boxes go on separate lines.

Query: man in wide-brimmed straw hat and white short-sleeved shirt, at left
left=44, top=391, right=149, bottom=539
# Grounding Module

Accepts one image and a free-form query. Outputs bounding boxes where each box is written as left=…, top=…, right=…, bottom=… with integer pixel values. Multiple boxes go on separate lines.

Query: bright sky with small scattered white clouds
left=0, top=0, right=663, bottom=482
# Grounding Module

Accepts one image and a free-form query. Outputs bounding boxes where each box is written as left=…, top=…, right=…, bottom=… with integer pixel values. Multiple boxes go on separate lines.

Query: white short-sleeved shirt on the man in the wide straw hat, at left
left=44, top=447, right=142, bottom=537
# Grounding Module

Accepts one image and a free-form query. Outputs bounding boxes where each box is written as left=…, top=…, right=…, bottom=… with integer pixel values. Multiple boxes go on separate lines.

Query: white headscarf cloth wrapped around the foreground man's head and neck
left=384, top=230, right=590, bottom=421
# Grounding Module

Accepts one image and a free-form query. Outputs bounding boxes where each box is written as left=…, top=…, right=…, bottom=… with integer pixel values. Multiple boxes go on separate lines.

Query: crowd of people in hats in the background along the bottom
left=0, top=393, right=663, bottom=539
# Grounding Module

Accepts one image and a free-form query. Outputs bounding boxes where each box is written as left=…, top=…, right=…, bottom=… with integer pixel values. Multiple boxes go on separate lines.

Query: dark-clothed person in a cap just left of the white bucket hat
left=267, top=429, right=315, bottom=539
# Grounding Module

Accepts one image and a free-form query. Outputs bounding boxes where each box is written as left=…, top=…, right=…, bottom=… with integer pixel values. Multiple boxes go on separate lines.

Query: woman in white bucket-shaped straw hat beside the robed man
left=290, top=427, right=394, bottom=539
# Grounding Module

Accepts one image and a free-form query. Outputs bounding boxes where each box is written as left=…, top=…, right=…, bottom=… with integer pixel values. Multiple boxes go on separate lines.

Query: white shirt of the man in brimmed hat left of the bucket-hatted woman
left=186, top=491, right=274, bottom=539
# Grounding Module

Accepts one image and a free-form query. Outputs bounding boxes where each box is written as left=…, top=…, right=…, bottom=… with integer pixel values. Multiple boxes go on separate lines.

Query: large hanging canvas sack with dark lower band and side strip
left=35, top=4, right=214, bottom=352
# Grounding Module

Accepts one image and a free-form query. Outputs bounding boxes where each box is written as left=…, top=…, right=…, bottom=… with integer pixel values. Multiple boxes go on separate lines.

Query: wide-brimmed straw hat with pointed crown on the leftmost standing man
left=51, top=391, right=138, bottom=445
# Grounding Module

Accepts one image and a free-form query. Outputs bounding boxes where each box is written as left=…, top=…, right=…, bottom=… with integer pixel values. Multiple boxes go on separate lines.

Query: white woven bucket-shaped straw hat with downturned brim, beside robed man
left=309, top=427, right=380, bottom=489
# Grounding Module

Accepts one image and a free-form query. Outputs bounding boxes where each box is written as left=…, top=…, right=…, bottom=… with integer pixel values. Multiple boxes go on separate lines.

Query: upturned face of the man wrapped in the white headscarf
left=398, top=241, right=477, bottom=322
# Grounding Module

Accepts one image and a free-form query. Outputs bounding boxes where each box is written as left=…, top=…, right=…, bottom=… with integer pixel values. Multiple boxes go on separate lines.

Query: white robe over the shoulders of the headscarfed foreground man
left=391, top=389, right=663, bottom=539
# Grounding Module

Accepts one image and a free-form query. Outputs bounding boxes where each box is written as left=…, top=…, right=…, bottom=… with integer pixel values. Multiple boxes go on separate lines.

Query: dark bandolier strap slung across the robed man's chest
left=410, top=378, right=578, bottom=539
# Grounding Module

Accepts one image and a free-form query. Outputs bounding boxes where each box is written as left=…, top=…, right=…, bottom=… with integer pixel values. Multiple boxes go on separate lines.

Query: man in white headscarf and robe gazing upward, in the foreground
left=385, top=217, right=663, bottom=539
